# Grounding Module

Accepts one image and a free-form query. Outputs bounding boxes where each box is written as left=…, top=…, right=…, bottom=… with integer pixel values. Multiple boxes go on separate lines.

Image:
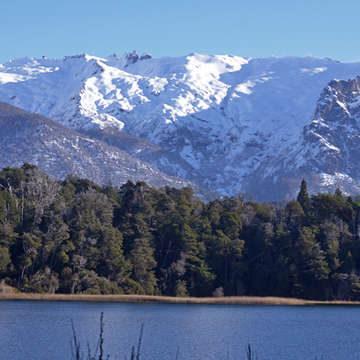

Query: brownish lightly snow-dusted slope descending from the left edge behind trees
left=0, top=102, right=198, bottom=188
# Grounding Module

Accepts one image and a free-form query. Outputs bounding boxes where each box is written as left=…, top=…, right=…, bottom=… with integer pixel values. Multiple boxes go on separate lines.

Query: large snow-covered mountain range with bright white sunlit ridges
left=0, top=52, right=360, bottom=199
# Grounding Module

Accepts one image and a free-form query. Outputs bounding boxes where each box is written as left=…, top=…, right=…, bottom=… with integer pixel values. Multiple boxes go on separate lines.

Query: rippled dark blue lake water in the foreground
left=0, top=301, right=360, bottom=360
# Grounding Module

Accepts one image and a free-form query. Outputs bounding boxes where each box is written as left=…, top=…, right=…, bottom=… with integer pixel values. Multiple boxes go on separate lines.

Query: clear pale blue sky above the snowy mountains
left=0, top=0, right=360, bottom=63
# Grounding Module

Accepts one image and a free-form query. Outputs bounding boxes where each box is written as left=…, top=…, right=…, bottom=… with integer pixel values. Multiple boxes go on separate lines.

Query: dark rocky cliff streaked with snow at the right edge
left=295, top=77, right=360, bottom=197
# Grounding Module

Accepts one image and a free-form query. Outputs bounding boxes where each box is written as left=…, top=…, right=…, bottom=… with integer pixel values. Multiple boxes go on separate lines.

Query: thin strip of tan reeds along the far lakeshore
left=0, top=293, right=360, bottom=306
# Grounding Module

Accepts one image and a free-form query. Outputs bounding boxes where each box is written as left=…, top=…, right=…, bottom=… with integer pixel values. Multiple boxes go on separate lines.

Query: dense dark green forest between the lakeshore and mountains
left=0, top=164, right=360, bottom=300
